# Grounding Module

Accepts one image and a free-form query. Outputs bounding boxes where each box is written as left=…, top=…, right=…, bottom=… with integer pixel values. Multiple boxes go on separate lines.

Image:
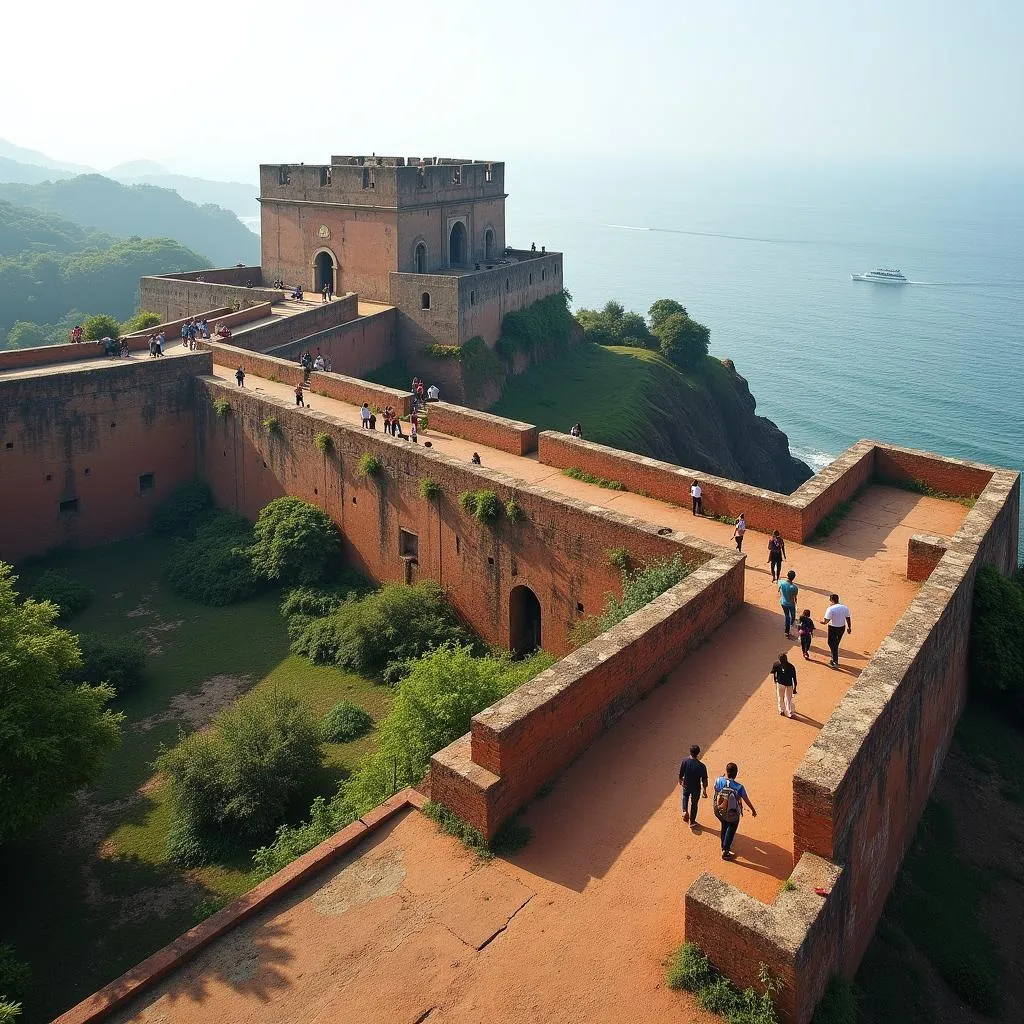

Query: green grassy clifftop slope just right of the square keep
left=490, top=345, right=697, bottom=452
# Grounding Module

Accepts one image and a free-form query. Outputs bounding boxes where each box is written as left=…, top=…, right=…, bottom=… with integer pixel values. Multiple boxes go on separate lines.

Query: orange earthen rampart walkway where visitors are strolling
left=37, top=348, right=965, bottom=1024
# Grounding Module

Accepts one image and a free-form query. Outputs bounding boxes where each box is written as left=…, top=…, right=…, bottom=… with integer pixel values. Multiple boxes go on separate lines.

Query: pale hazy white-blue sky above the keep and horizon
left=0, top=0, right=1024, bottom=180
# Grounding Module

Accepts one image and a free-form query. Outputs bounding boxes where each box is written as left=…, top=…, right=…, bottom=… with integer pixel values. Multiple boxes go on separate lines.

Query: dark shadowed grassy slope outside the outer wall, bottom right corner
left=854, top=705, right=1024, bottom=1024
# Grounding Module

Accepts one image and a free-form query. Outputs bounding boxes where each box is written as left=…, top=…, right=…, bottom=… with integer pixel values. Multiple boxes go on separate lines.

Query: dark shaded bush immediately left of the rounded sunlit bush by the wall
left=164, top=512, right=260, bottom=607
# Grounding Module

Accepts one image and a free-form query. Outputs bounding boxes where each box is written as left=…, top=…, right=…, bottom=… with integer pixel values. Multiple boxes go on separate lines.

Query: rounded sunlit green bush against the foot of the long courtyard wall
left=250, top=498, right=341, bottom=584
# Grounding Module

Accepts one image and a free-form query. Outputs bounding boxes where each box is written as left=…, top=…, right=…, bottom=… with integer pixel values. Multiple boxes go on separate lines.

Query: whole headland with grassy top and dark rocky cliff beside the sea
left=490, top=342, right=812, bottom=494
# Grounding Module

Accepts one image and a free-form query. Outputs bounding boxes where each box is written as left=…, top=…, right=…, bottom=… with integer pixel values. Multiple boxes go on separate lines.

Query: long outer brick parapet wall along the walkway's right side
left=686, top=464, right=1020, bottom=1024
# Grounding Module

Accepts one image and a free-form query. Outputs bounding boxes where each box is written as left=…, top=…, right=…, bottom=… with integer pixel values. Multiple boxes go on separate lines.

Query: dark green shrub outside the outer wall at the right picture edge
left=970, top=565, right=1024, bottom=714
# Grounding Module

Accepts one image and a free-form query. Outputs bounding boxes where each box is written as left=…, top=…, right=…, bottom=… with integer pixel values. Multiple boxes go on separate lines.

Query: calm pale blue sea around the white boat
left=505, top=155, right=1024, bottom=507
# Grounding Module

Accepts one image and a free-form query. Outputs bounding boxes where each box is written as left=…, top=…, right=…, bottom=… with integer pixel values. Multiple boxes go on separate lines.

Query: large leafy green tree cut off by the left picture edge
left=0, top=562, right=123, bottom=842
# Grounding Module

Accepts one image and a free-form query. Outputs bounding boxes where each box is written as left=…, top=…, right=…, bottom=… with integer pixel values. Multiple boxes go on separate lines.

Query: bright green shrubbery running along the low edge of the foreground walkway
left=253, top=644, right=554, bottom=874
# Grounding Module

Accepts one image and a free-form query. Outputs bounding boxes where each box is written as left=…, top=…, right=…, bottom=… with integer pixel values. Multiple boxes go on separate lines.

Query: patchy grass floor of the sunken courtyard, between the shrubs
left=0, top=538, right=392, bottom=1024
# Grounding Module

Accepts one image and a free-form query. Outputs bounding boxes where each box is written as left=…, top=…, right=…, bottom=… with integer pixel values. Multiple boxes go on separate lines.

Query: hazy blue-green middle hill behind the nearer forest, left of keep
left=0, top=174, right=260, bottom=266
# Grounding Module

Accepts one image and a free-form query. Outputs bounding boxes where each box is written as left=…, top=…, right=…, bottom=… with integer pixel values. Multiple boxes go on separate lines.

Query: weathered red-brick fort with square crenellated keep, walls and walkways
left=0, top=149, right=1020, bottom=1024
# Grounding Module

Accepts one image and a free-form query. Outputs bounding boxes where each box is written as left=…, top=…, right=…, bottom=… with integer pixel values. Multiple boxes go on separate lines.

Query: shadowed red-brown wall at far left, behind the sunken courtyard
left=0, top=345, right=212, bottom=562
